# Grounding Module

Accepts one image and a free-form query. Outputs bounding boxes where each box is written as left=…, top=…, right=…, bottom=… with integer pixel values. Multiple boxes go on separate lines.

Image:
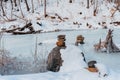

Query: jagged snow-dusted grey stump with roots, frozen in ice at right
left=94, top=29, right=120, bottom=53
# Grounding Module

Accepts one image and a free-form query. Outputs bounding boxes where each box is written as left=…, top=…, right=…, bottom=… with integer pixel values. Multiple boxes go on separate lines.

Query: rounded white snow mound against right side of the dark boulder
left=60, top=45, right=87, bottom=72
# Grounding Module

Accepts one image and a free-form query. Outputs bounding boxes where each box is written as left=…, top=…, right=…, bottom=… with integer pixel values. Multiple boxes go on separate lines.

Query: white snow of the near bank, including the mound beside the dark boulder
left=0, top=45, right=120, bottom=80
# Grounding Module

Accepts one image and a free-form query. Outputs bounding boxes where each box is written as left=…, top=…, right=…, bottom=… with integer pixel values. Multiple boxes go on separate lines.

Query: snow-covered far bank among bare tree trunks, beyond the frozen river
left=0, top=0, right=120, bottom=32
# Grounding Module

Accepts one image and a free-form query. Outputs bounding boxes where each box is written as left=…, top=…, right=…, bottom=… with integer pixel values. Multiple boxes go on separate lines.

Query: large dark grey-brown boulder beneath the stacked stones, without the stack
left=47, top=46, right=63, bottom=72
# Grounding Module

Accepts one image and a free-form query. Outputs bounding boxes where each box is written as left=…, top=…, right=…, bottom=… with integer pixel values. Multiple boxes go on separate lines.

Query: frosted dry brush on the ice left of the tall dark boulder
left=0, top=32, right=47, bottom=75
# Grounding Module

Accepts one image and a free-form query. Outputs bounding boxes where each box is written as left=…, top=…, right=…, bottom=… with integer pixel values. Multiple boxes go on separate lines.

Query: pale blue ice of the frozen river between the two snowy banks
left=3, top=29, right=120, bottom=72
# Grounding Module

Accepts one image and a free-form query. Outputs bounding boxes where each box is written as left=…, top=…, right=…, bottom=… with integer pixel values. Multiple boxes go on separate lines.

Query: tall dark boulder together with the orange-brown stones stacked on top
left=47, top=35, right=66, bottom=72
